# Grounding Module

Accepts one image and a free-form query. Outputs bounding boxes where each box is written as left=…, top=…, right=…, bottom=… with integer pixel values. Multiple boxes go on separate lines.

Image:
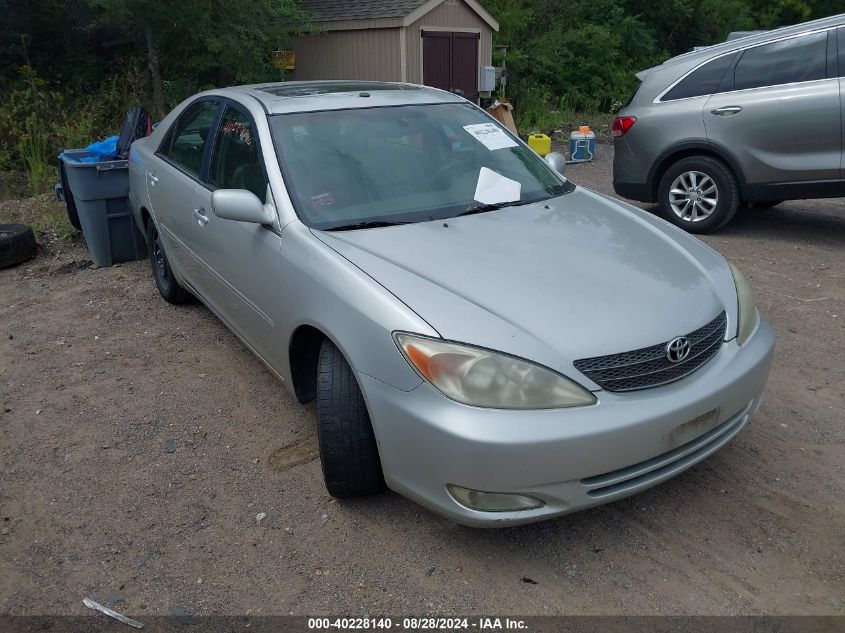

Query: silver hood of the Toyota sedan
left=314, top=188, right=736, bottom=383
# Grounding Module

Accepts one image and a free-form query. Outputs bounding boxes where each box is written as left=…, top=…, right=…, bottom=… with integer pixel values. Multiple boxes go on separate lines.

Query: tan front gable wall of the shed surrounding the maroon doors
left=406, top=0, right=493, bottom=84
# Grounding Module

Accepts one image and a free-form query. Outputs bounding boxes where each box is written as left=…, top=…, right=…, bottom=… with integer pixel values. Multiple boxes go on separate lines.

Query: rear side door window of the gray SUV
left=734, top=31, right=827, bottom=90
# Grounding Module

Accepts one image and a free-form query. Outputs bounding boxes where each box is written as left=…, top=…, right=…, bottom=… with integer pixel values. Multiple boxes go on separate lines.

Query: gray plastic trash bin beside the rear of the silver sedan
left=59, top=149, right=147, bottom=266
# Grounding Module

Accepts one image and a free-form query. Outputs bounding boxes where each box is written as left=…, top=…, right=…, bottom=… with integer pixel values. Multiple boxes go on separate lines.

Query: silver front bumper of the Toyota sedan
left=358, top=319, right=774, bottom=527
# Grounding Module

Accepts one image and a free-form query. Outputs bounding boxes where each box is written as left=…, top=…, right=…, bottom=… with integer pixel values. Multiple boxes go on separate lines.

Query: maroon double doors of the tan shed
left=422, top=31, right=480, bottom=102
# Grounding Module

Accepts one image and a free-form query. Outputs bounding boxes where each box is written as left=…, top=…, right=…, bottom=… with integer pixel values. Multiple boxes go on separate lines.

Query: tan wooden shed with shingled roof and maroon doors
left=293, top=0, right=499, bottom=101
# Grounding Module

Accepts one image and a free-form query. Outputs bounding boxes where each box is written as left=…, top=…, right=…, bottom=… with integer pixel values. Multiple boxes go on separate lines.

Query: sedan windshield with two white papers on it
left=270, top=103, right=574, bottom=230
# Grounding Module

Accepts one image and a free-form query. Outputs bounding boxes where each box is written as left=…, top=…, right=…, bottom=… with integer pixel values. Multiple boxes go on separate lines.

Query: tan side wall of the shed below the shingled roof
left=293, top=28, right=401, bottom=81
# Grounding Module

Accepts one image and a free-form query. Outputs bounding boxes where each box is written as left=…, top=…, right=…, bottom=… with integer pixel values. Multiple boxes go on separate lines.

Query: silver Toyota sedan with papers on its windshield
left=130, top=82, right=774, bottom=526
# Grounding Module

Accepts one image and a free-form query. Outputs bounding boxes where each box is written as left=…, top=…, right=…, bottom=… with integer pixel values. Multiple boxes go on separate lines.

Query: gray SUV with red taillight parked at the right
left=612, top=14, right=845, bottom=233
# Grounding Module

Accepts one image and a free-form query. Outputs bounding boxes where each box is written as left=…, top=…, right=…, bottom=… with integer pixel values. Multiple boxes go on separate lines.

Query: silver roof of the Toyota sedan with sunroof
left=221, top=81, right=466, bottom=114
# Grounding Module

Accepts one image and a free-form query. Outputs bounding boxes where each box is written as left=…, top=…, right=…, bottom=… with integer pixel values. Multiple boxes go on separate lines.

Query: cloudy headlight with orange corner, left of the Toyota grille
left=394, top=332, right=596, bottom=409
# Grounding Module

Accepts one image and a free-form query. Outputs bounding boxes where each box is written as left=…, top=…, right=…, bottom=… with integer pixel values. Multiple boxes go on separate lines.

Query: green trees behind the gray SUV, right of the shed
left=482, top=0, right=842, bottom=114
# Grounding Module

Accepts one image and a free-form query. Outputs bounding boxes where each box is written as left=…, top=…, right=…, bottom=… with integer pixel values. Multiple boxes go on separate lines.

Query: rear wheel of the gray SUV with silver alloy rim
left=657, top=156, right=739, bottom=233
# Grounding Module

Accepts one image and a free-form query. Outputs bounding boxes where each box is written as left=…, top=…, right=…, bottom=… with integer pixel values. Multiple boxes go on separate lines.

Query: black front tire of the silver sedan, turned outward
left=317, top=339, right=384, bottom=498
